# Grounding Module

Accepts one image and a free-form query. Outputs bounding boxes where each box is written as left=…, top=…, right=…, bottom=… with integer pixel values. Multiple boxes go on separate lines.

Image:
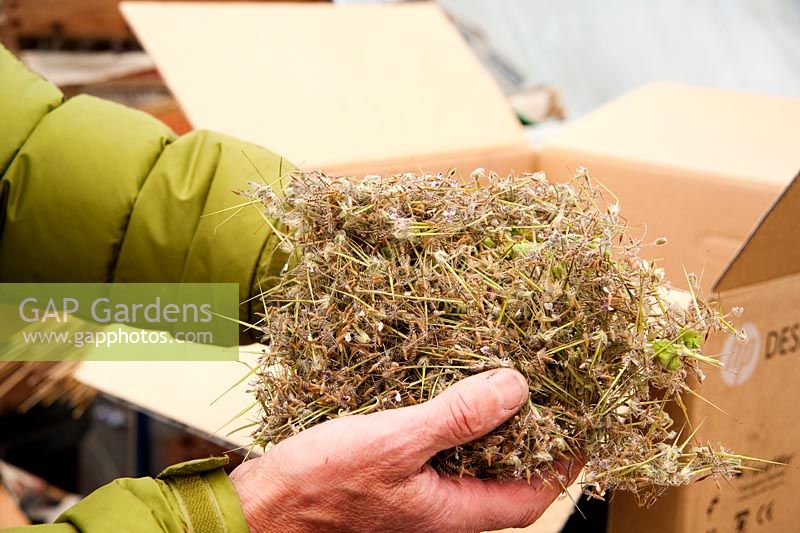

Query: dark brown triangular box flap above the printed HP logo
left=714, top=174, right=800, bottom=292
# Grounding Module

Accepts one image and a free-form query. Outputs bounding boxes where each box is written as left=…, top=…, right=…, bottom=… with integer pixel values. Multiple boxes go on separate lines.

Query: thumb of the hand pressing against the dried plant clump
left=399, top=368, right=528, bottom=465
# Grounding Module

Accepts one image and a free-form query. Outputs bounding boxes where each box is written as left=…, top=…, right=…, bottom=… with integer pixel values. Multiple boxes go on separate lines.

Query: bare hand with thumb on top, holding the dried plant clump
left=231, top=369, right=581, bottom=533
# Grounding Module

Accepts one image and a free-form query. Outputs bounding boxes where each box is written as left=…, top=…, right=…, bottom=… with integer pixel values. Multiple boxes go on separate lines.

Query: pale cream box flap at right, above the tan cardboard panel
left=542, top=83, right=800, bottom=189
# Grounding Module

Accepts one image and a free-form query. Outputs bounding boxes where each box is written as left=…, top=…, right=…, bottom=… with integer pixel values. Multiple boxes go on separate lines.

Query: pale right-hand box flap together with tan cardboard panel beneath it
left=538, top=84, right=800, bottom=290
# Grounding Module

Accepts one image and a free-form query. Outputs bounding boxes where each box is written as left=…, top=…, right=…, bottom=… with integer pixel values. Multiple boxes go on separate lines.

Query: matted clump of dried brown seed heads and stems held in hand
left=245, top=169, right=739, bottom=501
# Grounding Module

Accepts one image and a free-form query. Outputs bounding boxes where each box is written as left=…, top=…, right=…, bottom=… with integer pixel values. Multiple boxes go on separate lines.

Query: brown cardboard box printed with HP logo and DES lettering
left=609, top=175, right=800, bottom=533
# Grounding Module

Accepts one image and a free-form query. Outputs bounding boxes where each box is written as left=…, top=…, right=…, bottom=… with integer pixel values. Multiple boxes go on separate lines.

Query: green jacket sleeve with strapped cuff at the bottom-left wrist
left=3, top=457, right=249, bottom=533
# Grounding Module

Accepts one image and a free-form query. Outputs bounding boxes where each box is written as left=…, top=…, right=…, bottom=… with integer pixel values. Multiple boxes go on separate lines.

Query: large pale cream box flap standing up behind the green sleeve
left=121, top=2, right=527, bottom=168
